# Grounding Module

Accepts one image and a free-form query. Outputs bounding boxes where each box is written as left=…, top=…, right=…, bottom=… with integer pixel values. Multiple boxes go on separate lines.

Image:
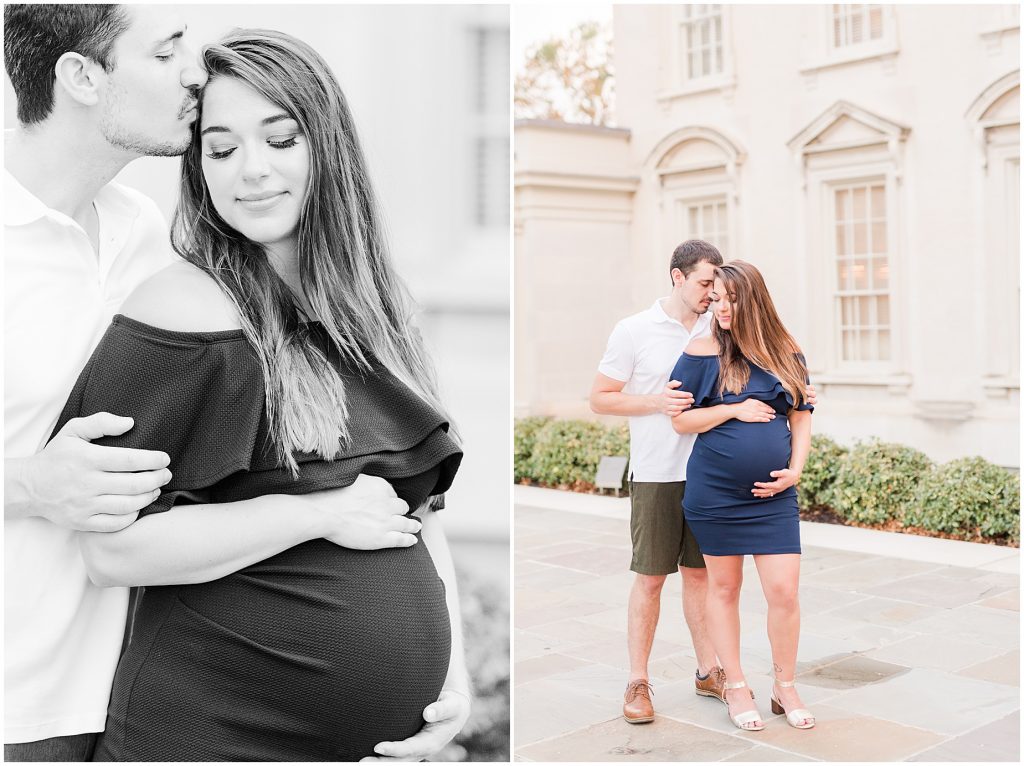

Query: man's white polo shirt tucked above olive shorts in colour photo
left=597, top=298, right=711, bottom=481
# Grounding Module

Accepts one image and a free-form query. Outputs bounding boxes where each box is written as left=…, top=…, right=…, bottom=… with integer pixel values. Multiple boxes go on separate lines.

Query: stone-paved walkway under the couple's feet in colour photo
left=513, top=486, right=1020, bottom=762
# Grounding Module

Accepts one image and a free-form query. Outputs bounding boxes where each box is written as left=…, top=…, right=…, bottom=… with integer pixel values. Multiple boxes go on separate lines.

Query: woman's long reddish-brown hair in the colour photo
left=713, top=261, right=807, bottom=407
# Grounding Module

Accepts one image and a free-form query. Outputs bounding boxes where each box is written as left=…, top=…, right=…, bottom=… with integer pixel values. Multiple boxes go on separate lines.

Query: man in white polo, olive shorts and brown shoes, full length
left=590, top=240, right=725, bottom=723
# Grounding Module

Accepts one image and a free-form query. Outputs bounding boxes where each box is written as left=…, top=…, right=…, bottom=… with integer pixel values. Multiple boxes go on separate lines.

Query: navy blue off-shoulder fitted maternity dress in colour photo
left=670, top=353, right=814, bottom=556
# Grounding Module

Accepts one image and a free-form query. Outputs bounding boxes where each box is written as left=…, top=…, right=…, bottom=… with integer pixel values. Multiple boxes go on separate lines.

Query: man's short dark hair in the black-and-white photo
left=3, top=4, right=129, bottom=125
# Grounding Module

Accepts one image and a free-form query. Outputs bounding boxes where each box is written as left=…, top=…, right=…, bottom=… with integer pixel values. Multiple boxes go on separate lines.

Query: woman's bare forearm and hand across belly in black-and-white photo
left=79, top=475, right=420, bottom=587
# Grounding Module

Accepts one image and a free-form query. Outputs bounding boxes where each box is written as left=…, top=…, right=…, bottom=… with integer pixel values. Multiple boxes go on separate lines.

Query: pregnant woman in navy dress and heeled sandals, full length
left=671, top=261, right=814, bottom=731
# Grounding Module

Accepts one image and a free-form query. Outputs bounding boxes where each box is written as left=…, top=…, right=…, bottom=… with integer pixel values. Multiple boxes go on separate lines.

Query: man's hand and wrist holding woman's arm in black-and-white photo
left=4, top=413, right=171, bottom=533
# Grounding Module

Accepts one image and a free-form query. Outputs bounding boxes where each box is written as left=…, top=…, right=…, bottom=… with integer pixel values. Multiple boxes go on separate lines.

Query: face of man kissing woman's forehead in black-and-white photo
left=100, top=5, right=206, bottom=157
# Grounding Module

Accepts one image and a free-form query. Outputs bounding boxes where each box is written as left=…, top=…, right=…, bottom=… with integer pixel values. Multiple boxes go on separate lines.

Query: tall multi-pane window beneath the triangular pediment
left=833, top=180, right=892, bottom=363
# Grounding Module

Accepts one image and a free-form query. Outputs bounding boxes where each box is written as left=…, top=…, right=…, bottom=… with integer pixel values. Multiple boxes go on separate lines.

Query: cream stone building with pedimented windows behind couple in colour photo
left=514, top=4, right=1020, bottom=467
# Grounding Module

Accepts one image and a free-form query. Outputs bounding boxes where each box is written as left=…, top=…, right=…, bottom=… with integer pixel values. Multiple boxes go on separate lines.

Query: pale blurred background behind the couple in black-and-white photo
left=4, top=4, right=511, bottom=760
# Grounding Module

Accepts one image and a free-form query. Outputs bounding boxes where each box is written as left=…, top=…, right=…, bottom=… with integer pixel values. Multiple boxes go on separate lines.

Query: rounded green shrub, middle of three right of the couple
left=827, top=439, right=932, bottom=524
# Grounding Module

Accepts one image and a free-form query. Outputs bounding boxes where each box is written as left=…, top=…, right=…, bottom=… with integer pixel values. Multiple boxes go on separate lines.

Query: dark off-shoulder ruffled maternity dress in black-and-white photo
left=51, top=316, right=462, bottom=761
